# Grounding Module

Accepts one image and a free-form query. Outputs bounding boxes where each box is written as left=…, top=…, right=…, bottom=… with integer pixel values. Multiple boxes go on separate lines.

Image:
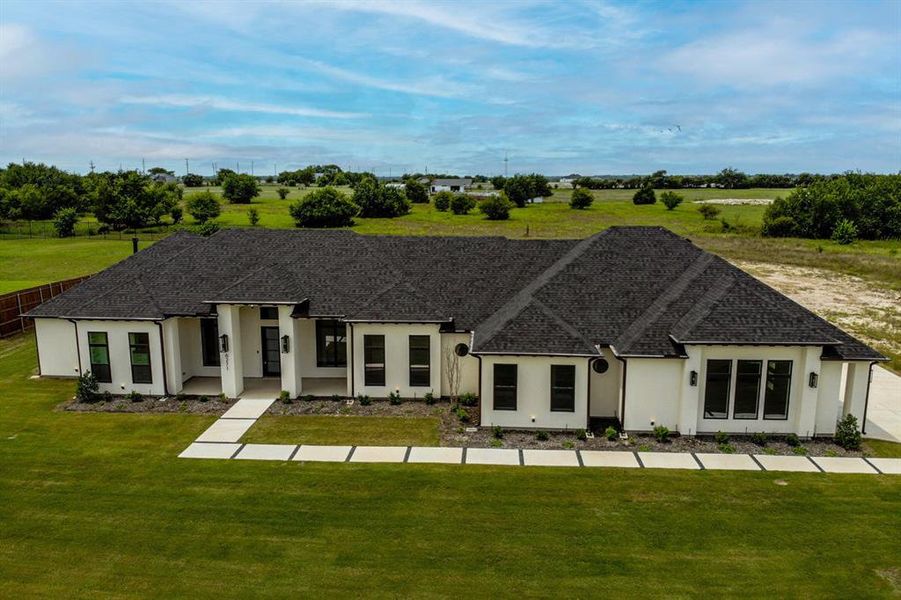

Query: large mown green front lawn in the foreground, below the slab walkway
left=0, top=337, right=901, bottom=598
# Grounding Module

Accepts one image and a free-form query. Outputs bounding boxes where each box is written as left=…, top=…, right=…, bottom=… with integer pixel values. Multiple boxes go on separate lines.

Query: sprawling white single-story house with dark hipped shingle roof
left=27, top=227, right=885, bottom=437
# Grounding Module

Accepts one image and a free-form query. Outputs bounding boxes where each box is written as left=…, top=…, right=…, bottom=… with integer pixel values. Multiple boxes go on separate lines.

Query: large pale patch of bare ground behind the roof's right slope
left=733, top=261, right=901, bottom=371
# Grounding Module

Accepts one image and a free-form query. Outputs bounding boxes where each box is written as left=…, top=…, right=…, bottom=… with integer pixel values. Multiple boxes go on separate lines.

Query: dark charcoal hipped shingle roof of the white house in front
left=29, top=227, right=882, bottom=360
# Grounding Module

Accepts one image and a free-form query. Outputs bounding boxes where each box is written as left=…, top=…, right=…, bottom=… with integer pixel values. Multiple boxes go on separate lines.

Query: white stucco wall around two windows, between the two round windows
left=480, top=355, right=588, bottom=429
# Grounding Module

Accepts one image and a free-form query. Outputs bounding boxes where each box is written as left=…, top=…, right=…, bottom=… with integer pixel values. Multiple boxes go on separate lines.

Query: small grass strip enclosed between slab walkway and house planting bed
left=241, top=415, right=438, bottom=446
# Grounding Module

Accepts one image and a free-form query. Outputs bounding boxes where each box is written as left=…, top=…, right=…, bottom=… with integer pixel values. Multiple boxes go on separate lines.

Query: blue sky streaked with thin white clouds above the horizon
left=0, top=0, right=901, bottom=175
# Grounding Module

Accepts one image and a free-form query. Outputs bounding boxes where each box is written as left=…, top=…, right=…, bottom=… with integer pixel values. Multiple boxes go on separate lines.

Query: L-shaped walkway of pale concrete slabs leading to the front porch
left=178, top=396, right=901, bottom=475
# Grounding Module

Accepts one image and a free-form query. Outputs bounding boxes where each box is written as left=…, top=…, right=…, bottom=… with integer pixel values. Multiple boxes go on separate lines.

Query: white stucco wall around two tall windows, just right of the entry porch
left=353, top=323, right=441, bottom=398
